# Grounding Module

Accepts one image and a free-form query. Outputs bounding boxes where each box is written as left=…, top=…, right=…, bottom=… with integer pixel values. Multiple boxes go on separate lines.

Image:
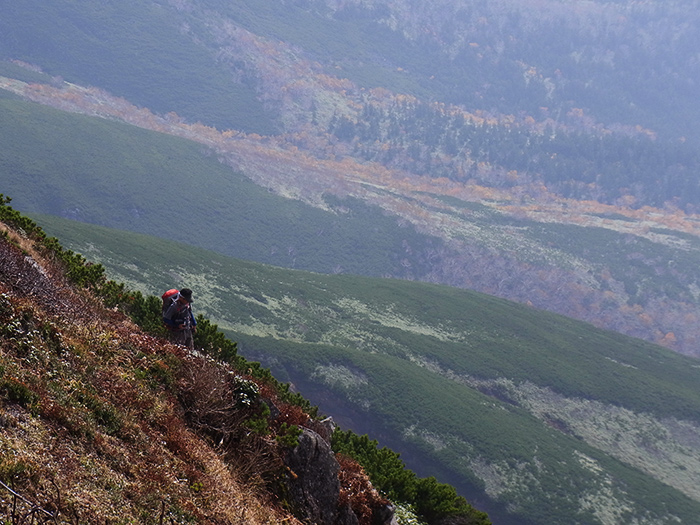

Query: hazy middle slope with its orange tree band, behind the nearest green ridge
left=0, top=81, right=700, bottom=355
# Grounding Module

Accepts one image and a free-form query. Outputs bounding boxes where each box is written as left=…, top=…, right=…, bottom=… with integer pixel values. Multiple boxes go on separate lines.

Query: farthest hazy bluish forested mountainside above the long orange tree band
left=5, top=0, right=700, bottom=210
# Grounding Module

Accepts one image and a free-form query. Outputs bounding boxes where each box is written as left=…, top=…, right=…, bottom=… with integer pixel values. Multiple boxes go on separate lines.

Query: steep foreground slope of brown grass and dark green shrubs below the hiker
left=0, top=199, right=490, bottom=525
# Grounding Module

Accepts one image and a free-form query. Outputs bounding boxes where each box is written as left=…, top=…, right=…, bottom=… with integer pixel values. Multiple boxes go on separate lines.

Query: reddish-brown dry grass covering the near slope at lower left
left=0, top=234, right=304, bottom=525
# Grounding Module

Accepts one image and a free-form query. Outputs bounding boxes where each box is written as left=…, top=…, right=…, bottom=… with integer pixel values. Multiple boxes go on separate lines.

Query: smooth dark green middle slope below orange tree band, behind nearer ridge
left=0, top=91, right=440, bottom=275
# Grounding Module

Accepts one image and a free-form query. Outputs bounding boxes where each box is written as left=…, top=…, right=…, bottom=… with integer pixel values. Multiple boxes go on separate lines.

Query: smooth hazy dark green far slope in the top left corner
left=0, top=0, right=274, bottom=133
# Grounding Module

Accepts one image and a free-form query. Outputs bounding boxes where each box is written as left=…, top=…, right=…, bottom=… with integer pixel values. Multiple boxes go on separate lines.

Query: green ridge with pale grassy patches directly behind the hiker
left=32, top=217, right=700, bottom=524
